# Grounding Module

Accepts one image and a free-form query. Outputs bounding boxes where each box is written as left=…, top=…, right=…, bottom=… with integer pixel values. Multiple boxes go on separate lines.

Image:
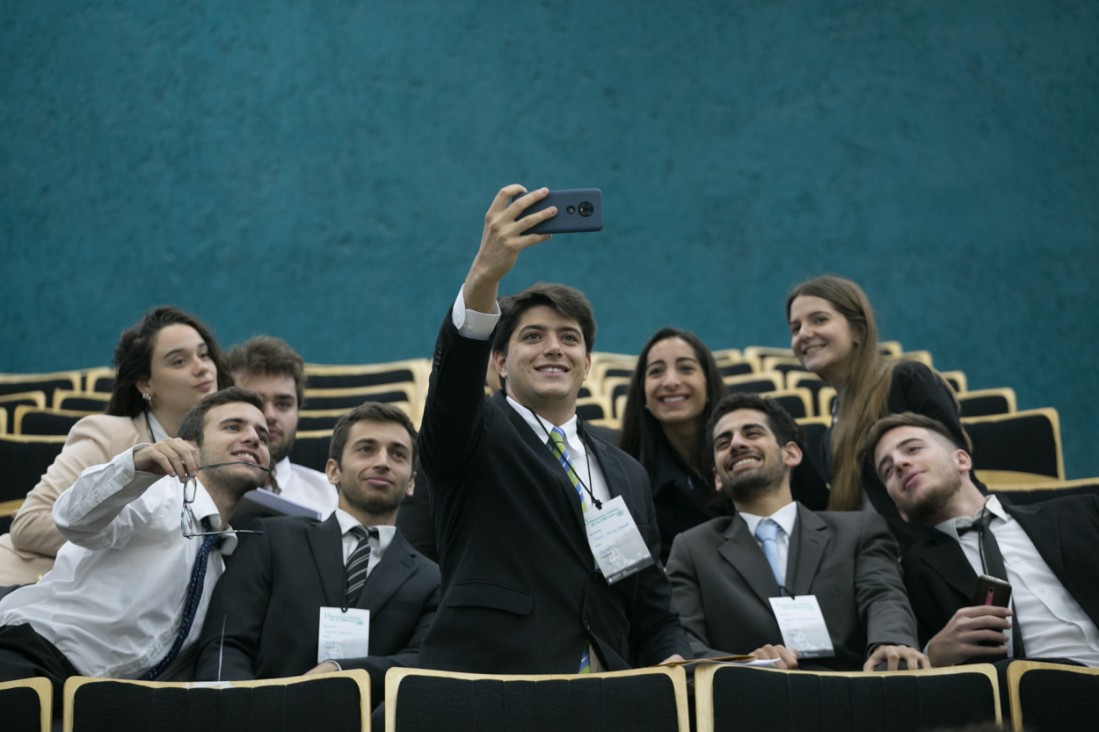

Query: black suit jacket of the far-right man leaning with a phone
left=903, top=496, right=1099, bottom=644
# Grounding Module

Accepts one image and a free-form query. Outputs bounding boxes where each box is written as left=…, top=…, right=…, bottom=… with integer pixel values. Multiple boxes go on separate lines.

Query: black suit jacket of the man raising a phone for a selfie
left=420, top=313, right=689, bottom=674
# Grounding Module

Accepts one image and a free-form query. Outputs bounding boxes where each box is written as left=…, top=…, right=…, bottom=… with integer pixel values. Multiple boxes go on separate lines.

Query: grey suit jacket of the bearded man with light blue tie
left=668, top=504, right=919, bottom=670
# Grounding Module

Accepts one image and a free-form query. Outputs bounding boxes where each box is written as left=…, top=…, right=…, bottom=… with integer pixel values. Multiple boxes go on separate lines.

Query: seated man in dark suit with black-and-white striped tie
left=196, top=402, right=439, bottom=705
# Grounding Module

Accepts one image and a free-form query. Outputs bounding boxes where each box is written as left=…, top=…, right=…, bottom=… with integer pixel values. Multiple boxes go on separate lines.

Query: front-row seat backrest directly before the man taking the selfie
left=386, top=666, right=689, bottom=732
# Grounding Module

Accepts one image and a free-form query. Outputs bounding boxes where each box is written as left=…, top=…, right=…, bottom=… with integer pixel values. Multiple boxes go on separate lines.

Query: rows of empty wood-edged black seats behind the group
left=0, top=342, right=1099, bottom=531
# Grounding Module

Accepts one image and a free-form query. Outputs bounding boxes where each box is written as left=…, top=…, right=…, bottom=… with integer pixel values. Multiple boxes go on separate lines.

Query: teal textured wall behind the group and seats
left=0, top=0, right=1099, bottom=475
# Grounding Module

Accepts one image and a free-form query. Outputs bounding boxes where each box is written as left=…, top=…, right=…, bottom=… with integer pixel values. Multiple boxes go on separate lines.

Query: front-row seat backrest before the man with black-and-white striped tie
left=65, top=669, right=370, bottom=732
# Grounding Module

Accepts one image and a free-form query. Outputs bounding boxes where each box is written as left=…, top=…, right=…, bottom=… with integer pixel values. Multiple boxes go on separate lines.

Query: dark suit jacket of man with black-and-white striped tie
left=196, top=514, right=440, bottom=703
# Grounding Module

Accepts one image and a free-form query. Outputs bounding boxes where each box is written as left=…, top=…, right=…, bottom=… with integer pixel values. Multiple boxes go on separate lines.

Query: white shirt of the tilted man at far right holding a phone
left=935, top=496, right=1099, bottom=666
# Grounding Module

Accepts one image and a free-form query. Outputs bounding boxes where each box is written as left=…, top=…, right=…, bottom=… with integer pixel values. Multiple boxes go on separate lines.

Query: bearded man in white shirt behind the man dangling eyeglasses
left=225, top=335, right=338, bottom=519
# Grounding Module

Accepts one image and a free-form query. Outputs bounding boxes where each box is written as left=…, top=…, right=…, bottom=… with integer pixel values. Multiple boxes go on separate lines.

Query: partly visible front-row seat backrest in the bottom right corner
left=1008, top=661, right=1099, bottom=732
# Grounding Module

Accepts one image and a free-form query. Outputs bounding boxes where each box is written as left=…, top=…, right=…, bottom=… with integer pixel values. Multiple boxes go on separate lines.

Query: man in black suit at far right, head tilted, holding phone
left=866, top=412, right=1099, bottom=666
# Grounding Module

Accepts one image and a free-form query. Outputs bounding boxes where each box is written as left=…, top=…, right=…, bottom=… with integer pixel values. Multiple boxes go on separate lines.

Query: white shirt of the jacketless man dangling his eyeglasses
left=0, top=445, right=236, bottom=680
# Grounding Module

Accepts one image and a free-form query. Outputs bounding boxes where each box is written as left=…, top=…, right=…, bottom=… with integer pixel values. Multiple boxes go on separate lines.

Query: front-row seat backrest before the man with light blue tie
left=695, top=664, right=1000, bottom=732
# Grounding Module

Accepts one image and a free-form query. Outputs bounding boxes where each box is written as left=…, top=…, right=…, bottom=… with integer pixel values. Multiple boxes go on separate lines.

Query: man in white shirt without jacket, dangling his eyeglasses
left=0, top=387, right=270, bottom=702
